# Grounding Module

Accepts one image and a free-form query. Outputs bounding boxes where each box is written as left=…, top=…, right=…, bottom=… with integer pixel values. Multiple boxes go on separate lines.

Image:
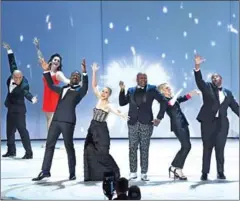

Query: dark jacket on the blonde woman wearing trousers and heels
left=161, top=94, right=191, bottom=131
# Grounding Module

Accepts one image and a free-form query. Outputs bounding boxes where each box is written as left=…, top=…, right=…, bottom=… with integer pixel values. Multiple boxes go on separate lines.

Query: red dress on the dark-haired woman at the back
left=42, top=75, right=60, bottom=112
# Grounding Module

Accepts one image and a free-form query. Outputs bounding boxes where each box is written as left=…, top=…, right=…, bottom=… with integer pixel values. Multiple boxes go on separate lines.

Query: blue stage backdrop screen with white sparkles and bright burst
left=1, top=1, right=239, bottom=139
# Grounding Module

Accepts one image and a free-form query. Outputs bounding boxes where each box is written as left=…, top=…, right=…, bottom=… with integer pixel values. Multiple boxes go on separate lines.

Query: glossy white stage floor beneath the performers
left=1, top=139, right=239, bottom=200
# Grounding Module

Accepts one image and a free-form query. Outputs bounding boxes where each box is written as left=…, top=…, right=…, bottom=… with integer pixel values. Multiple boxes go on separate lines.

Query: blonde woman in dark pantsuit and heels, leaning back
left=158, top=83, right=200, bottom=180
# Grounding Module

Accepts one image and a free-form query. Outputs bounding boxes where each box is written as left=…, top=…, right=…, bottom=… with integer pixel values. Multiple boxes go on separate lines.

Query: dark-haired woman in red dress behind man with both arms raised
left=33, top=38, right=70, bottom=147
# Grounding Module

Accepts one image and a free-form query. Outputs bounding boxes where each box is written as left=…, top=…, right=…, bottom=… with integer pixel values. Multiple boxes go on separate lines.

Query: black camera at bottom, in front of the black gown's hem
left=102, top=172, right=116, bottom=200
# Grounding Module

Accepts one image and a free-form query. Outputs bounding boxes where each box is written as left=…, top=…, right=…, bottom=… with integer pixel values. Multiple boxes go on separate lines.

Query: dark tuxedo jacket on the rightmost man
left=194, top=70, right=239, bottom=122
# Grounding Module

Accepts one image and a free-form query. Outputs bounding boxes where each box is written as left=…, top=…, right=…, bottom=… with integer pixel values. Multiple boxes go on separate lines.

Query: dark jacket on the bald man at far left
left=4, top=53, right=33, bottom=113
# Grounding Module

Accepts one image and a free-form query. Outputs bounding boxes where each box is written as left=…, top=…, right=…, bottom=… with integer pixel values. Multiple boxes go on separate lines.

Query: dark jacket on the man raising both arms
left=43, top=72, right=88, bottom=125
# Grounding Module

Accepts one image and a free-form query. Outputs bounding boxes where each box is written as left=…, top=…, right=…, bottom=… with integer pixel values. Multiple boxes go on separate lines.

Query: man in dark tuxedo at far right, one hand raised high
left=194, top=56, right=239, bottom=180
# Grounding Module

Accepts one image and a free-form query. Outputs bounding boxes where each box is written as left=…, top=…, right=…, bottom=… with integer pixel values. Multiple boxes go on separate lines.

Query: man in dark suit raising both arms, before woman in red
left=33, top=57, right=88, bottom=181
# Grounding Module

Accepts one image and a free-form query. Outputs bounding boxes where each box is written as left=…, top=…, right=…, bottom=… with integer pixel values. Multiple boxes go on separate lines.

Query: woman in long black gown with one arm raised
left=84, top=63, right=128, bottom=181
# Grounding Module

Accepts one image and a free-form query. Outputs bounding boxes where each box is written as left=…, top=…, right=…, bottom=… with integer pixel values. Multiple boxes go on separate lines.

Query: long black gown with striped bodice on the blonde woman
left=84, top=108, right=120, bottom=181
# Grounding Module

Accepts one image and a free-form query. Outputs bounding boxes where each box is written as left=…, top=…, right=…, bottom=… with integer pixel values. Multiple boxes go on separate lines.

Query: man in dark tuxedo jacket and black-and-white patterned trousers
left=119, top=73, right=165, bottom=181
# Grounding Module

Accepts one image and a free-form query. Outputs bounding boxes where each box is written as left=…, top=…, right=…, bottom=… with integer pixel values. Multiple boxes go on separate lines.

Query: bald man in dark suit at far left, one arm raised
left=2, top=43, right=37, bottom=159
